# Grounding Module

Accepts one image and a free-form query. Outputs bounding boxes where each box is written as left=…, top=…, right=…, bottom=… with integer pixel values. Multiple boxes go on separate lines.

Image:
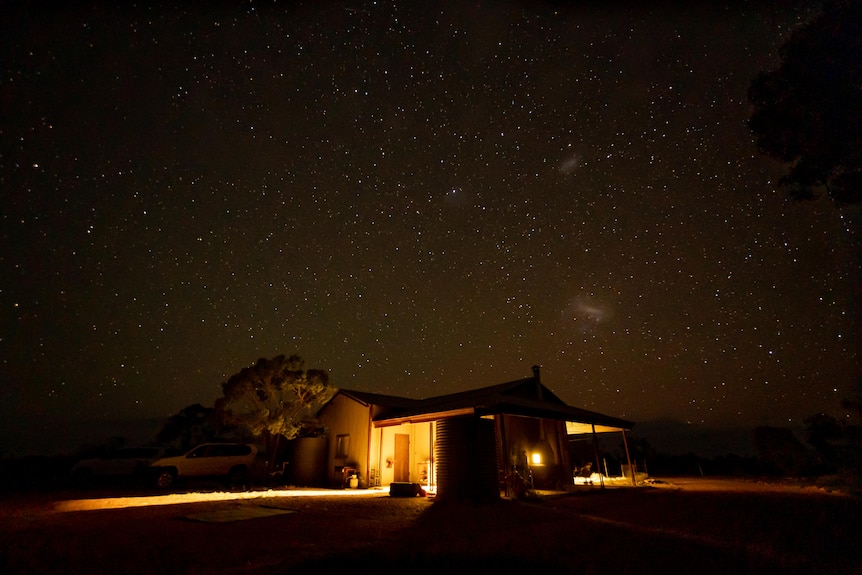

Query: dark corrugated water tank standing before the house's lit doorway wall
left=434, top=417, right=500, bottom=502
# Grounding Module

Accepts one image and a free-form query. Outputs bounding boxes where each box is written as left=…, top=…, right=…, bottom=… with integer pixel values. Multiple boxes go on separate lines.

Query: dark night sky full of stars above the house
left=0, top=1, right=862, bottom=456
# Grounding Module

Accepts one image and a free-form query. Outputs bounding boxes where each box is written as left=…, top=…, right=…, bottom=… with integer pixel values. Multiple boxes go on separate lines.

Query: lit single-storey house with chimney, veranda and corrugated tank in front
left=318, top=367, right=633, bottom=497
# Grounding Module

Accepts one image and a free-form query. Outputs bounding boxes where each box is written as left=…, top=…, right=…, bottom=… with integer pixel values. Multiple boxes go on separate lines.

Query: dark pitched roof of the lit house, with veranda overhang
left=324, top=374, right=634, bottom=435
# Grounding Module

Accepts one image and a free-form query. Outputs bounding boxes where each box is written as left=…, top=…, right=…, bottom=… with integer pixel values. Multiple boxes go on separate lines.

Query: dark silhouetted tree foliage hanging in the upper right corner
left=748, top=0, right=862, bottom=204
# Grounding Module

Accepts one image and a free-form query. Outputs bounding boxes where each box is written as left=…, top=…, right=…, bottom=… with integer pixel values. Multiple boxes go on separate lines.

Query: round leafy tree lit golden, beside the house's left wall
left=215, top=355, right=333, bottom=470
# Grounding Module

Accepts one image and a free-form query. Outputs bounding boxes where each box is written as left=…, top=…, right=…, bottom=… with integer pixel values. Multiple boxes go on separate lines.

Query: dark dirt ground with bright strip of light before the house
left=0, top=479, right=862, bottom=575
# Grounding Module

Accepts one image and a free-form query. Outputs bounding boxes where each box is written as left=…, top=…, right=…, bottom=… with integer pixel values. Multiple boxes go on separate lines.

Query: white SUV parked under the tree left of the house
left=150, top=443, right=257, bottom=488
